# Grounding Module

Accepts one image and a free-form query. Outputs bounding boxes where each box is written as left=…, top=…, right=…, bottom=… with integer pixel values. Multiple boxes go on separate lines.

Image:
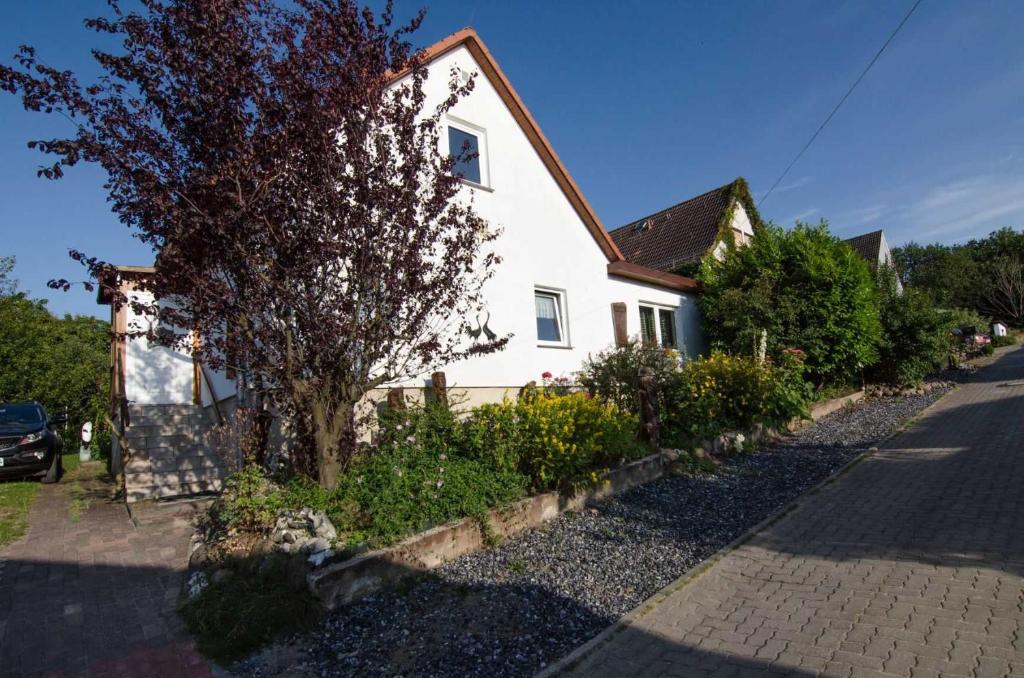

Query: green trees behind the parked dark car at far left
left=0, top=292, right=110, bottom=452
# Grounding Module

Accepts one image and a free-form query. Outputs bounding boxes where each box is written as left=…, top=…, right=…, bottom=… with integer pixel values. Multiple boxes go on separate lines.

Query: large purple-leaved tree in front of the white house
left=0, top=0, right=507, bottom=488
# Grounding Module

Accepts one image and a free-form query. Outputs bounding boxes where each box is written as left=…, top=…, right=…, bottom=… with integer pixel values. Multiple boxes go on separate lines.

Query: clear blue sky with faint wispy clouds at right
left=0, top=0, right=1024, bottom=314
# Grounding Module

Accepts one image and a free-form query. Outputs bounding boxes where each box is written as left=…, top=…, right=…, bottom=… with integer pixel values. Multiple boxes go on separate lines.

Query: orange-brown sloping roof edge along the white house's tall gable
left=394, top=28, right=623, bottom=261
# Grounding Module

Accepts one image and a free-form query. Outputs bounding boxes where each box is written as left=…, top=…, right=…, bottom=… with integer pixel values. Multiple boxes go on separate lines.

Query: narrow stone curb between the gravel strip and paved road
left=534, top=384, right=961, bottom=678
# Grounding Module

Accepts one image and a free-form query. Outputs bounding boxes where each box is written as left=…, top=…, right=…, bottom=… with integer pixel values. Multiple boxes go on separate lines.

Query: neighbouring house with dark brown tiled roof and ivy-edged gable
left=610, top=178, right=760, bottom=276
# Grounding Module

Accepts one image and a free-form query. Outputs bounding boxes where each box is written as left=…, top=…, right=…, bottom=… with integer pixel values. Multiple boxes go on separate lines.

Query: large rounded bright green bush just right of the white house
left=699, top=221, right=881, bottom=384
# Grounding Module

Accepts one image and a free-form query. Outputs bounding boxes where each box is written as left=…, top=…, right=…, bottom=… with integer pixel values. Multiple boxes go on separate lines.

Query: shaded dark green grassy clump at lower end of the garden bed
left=178, top=563, right=321, bottom=662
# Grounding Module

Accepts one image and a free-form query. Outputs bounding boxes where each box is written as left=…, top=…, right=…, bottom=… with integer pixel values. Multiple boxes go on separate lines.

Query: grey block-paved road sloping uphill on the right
left=574, top=348, right=1024, bottom=677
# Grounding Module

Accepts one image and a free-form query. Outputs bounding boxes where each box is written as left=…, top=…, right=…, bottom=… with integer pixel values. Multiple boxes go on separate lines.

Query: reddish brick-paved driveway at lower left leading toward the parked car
left=0, top=464, right=210, bottom=678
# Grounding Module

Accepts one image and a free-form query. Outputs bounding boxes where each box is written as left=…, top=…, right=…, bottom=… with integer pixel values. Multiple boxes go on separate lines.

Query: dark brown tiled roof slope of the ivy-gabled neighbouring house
left=610, top=183, right=733, bottom=270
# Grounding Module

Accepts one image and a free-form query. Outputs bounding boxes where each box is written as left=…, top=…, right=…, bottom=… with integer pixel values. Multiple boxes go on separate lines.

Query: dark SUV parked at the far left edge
left=0, top=402, right=67, bottom=482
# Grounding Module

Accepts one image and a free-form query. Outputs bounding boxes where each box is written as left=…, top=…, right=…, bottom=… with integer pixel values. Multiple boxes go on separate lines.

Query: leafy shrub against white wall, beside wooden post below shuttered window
left=577, top=339, right=680, bottom=414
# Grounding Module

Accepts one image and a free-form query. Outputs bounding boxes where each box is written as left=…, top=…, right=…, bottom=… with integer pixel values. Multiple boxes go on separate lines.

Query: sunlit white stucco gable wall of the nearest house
left=393, top=47, right=702, bottom=387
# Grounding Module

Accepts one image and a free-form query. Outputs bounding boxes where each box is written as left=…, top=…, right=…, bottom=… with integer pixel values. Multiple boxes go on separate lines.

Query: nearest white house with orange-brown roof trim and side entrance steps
left=100, top=29, right=704, bottom=499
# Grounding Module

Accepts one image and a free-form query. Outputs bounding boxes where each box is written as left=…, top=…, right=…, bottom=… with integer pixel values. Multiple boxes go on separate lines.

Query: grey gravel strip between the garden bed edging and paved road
left=234, top=387, right=949, bottom=677
